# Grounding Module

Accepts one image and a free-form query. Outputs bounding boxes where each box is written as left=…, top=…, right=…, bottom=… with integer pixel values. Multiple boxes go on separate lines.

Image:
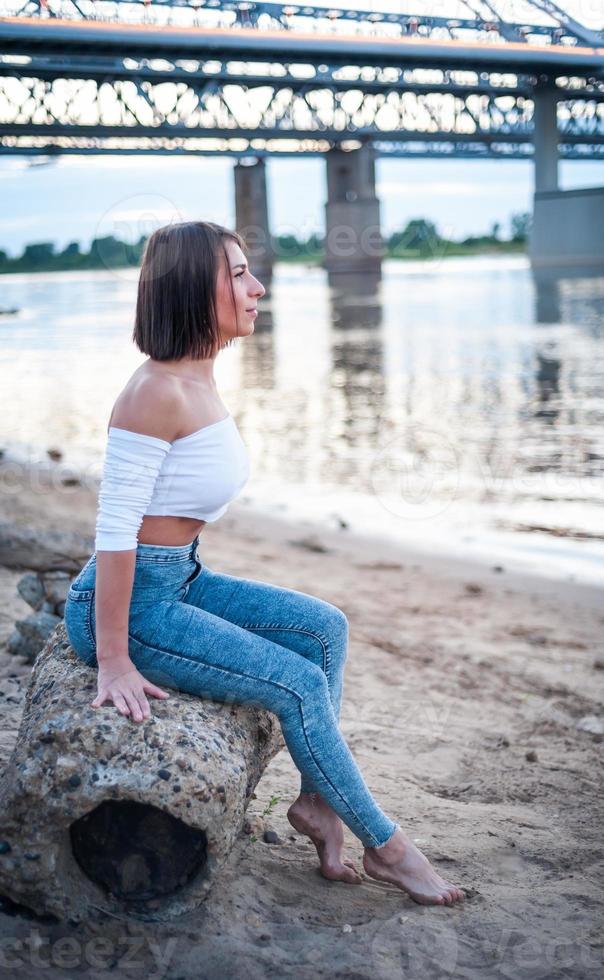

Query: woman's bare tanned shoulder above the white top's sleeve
left=109, top=372, right=185, bottom=442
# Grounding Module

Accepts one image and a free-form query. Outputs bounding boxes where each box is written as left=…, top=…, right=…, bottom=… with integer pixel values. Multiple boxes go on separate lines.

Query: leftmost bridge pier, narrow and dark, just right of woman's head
left=234, top=160, right=275, bottom=293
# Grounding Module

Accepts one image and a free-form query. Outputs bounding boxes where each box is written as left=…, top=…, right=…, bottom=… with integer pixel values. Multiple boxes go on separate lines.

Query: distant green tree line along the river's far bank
left=0, top=213, right=531, bottom=273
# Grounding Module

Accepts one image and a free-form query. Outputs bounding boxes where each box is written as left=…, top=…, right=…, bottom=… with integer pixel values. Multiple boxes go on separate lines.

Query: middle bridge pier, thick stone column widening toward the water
left=324, top=146, right=384, bottom=281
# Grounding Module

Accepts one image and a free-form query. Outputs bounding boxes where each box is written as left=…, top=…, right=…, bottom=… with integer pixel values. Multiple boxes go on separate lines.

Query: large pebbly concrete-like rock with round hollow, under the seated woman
left=0, top=623, right=284, bottom=921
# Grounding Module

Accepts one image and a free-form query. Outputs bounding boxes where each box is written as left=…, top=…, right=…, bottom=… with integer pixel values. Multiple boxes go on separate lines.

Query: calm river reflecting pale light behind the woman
left=0, top=256, right=604, bottom=583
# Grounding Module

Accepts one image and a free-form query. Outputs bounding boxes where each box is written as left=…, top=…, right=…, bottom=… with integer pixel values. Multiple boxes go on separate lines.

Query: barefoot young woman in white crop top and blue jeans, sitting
left=65, top=221, right=464, bottom=905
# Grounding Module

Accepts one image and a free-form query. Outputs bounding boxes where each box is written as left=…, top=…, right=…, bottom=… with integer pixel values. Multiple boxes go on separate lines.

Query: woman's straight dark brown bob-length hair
left=132, top=221, right=245, bottom=361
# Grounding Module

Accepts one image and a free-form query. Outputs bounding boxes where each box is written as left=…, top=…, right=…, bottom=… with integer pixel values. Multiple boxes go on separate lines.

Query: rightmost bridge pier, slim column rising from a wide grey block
left=529, top=87, right=604, bottom=276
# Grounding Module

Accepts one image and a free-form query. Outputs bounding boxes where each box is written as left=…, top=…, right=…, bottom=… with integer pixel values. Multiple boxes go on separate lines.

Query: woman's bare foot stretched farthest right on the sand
left=363, top=829, right=466, bottom=905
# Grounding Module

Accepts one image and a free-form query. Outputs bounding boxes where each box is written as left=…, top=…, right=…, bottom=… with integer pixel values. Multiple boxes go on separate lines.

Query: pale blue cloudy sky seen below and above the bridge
left=0, top=0, right=604, bottom=256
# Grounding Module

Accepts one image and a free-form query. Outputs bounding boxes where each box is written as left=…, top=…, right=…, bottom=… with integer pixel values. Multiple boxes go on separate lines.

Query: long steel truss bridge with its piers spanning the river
left=0, top=0, right=604, bottom=276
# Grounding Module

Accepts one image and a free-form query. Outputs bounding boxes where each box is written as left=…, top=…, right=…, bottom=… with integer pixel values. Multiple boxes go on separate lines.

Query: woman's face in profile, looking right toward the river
left=216, top=239, right=266, bottom=343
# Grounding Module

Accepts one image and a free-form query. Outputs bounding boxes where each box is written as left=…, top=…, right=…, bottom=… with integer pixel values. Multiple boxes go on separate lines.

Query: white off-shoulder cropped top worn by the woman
left=95, top=414, right=250, bottom=551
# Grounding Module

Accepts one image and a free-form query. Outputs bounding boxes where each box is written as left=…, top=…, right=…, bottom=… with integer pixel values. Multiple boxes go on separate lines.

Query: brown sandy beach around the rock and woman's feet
left=0, top=463, right=604, bottom=980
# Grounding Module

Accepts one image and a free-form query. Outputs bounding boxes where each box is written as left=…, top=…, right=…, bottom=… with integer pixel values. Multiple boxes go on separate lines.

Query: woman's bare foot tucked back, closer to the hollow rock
left=287, top=793, right=363, bottom=885
